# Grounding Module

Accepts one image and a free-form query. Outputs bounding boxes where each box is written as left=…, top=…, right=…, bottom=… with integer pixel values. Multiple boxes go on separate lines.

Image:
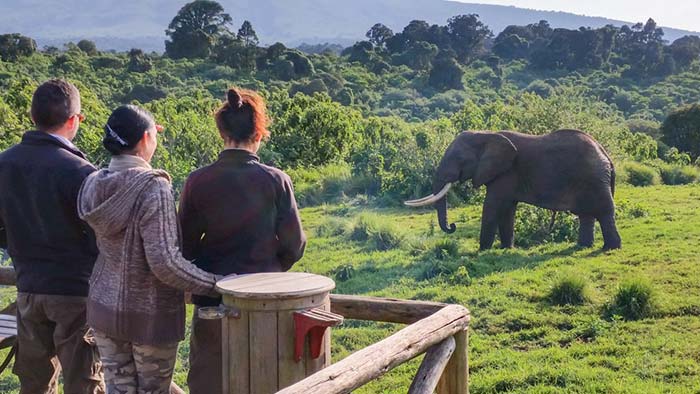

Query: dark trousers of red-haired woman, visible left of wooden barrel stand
left=187, top=306, right=223, bottom=394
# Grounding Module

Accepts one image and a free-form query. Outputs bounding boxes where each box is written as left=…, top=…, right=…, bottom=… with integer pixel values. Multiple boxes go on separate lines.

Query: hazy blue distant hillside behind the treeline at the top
left=0, top=0, right=700, bottom=51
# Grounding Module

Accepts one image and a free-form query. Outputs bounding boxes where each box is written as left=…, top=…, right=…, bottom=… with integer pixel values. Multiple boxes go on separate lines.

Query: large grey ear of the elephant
left=472, top=133, right=518, bottom=187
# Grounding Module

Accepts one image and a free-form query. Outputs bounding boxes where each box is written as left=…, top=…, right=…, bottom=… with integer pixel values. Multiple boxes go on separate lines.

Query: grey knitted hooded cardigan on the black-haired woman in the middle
left=78, top=156, right=216, bottom=345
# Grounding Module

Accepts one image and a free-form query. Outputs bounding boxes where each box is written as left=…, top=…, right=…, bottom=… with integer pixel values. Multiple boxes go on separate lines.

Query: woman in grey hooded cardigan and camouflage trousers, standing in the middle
left=78, top=106, right=217, bottom=393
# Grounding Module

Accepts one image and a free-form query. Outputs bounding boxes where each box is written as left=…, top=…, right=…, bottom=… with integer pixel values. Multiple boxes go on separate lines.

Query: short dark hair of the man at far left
left=32, top=79, right=80, bottom=131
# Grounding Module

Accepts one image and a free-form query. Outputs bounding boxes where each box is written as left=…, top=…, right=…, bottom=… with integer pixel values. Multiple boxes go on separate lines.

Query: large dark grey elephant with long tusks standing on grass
left=405, top=129, right=622, bottom=250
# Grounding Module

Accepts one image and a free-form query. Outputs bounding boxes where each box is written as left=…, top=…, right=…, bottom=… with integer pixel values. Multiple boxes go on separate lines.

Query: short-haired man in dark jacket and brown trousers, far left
left=0, top=80, right=105, bottom=394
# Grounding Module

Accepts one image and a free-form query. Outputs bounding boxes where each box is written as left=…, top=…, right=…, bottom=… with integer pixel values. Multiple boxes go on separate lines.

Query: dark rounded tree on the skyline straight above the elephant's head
left=447, top=14, right=493, bottom=62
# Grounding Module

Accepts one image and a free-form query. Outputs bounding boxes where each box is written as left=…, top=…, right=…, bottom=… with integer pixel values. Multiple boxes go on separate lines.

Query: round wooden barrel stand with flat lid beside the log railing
left=217, top=273, right=335, bottom=394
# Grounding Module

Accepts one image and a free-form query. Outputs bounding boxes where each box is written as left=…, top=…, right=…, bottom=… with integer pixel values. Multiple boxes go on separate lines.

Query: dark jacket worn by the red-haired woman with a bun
left=179, top=149, right=306, bottom=305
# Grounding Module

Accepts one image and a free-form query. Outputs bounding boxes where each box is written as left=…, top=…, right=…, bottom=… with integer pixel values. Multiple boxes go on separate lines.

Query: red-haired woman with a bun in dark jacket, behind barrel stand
left=180, top=88, right=306, bottom=394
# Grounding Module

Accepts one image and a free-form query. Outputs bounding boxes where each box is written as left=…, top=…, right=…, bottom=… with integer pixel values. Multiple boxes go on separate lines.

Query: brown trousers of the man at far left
left=13, top=293, right=105, bottom=394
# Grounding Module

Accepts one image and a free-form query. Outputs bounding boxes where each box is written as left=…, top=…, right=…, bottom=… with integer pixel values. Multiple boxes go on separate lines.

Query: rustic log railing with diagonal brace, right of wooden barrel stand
left=0, top=267, right=470, bottom=394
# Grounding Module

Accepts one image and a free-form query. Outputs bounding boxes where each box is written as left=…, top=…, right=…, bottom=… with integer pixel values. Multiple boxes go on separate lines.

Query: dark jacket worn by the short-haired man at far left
left=0, top=131, right=97, bottom=297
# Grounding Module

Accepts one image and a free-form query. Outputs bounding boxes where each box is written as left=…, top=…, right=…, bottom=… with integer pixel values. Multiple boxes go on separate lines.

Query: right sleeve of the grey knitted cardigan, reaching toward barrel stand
left=139, top=178, right=218, bottom=296
